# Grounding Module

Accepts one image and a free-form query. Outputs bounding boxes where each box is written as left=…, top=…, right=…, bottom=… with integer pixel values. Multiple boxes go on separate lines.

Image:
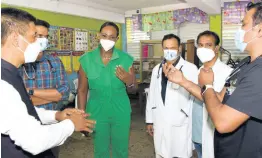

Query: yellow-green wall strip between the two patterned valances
left=209, top=14, right=222, bottom=44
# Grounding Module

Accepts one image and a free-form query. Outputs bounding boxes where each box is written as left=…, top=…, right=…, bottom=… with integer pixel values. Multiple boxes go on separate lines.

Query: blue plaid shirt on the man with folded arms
left=20, top=54, right=69, bottom=110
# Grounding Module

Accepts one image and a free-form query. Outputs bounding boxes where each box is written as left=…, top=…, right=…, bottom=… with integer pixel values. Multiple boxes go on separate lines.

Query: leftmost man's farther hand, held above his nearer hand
left=56, top=108, right=88, bottom=121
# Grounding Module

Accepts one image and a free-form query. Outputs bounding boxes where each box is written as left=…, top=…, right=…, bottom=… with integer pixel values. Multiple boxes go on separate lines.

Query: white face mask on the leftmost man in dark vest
left=18, top=35, right=41, bottom=63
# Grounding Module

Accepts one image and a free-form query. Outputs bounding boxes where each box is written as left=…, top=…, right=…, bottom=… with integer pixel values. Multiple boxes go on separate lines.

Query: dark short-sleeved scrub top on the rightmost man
left=215, top=57, right=262, bottom=158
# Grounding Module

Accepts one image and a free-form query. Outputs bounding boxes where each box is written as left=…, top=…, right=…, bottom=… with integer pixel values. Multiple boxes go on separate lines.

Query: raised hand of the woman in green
left=116, top=65, right=134, bottom=85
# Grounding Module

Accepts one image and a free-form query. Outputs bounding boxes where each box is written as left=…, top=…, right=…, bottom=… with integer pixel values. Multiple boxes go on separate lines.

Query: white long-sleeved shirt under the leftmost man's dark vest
left=0, top=61, right=74, bottom=155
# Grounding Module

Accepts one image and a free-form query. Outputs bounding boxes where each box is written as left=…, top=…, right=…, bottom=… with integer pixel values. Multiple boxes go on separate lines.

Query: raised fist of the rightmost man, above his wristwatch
left=198, top=68, right=214, bottom=87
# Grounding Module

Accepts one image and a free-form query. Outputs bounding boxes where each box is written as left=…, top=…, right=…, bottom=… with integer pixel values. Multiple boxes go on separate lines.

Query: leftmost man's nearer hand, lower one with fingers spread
left=69, top=114, right=96, bottom=133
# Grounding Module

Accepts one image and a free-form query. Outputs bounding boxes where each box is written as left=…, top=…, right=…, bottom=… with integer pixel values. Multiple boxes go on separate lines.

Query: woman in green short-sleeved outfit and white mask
left=78, top=22, right=135, bottom=158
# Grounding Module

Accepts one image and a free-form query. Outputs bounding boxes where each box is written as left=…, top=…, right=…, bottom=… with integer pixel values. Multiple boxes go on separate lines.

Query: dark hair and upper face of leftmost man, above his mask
left=1, top=7, right=36, bottom=45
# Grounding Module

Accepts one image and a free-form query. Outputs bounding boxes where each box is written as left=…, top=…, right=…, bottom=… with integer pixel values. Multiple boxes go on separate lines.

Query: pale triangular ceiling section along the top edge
left=60, top=0, right=186, bottom=13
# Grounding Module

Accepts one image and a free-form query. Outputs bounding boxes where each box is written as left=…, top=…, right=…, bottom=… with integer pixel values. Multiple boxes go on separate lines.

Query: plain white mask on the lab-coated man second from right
left=197, top=48, right=215, bottom=63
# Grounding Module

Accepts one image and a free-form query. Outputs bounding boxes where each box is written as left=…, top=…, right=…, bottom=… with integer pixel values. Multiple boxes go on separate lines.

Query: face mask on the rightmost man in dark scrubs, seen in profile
left=235, top=26, right=256, bottom=52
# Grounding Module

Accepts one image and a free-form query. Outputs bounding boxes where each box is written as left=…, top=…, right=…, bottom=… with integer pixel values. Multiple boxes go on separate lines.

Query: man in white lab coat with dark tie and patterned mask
left=146, top=34, right=198, bottom=158
